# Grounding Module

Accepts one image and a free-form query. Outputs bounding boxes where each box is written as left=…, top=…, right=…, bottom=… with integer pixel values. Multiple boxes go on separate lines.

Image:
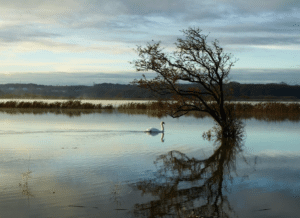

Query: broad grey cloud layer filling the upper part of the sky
left=0, top=0, right=300, bottom=53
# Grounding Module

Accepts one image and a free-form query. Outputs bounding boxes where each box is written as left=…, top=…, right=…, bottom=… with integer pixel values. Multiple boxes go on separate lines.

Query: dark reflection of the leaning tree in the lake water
left=133, top=120, right=247, bottom=218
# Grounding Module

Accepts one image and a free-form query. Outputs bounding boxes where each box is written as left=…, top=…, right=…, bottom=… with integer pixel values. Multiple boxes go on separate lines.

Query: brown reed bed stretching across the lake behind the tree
left=0, top=100, right=300, bottom=121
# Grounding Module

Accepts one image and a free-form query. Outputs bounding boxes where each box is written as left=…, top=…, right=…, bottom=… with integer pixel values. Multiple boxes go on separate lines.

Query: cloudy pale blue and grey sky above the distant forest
left=0, top=0, right=300, bottom=85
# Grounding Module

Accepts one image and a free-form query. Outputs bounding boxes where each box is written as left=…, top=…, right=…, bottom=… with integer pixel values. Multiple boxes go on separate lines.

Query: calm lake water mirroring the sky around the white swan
left=0, top=111, right=300, bottom=218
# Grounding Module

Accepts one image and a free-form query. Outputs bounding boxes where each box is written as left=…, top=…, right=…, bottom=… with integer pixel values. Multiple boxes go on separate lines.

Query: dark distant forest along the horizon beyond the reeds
left=0, top=82, right=300, bottom=100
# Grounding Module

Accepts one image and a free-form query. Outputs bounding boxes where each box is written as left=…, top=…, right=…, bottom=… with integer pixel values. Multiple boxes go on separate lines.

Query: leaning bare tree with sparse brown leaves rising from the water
left=131, top=28, right=237, bottom=136
